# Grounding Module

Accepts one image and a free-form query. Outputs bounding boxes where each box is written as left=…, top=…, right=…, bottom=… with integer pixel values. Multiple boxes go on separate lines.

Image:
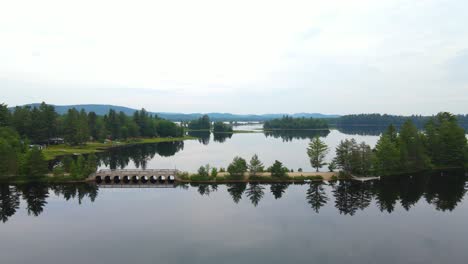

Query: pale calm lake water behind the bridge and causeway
left=99, top=125, right=381, bottom=172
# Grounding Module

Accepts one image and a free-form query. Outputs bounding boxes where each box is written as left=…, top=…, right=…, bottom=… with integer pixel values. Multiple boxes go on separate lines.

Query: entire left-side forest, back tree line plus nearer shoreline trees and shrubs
left=0, top=103, right=184, bottom=177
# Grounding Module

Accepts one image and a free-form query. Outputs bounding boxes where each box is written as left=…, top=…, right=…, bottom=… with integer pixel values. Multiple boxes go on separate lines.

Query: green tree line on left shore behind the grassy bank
left=0, top=103, right=184, bottom=145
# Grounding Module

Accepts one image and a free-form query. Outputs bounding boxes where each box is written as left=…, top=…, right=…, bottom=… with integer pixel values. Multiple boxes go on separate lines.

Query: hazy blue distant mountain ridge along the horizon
left=11, top=104, right=340, bottom=121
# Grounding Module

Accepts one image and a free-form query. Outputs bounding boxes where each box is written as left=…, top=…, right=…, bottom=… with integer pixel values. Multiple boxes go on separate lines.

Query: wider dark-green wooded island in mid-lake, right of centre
left=263, top=116, right=328, bottom=130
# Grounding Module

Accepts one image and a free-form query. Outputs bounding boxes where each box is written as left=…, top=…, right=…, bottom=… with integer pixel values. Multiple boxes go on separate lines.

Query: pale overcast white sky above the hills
left=0, top=0, right=468, bottom=115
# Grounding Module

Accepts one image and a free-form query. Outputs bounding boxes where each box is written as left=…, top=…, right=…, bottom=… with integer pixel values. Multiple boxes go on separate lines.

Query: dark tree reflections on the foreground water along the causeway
left=0, top=171, right=467, bottom=222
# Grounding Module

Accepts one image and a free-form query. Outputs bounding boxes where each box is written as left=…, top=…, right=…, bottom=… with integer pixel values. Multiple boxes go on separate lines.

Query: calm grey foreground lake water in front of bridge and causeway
left=0, top=172, right=468, bottom=264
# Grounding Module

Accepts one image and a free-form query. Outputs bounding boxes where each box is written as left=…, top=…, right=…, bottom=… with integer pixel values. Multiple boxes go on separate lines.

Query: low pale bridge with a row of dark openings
left=88, top=169, right=179, bottom=187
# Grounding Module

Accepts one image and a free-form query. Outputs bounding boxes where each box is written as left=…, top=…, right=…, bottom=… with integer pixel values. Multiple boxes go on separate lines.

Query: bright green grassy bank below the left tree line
left=43, top=136, right=196, bottom=160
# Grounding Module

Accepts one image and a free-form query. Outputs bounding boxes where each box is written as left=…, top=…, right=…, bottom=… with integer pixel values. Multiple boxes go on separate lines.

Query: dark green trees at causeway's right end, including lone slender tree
left=308, top=113, right=468, bottom=176
